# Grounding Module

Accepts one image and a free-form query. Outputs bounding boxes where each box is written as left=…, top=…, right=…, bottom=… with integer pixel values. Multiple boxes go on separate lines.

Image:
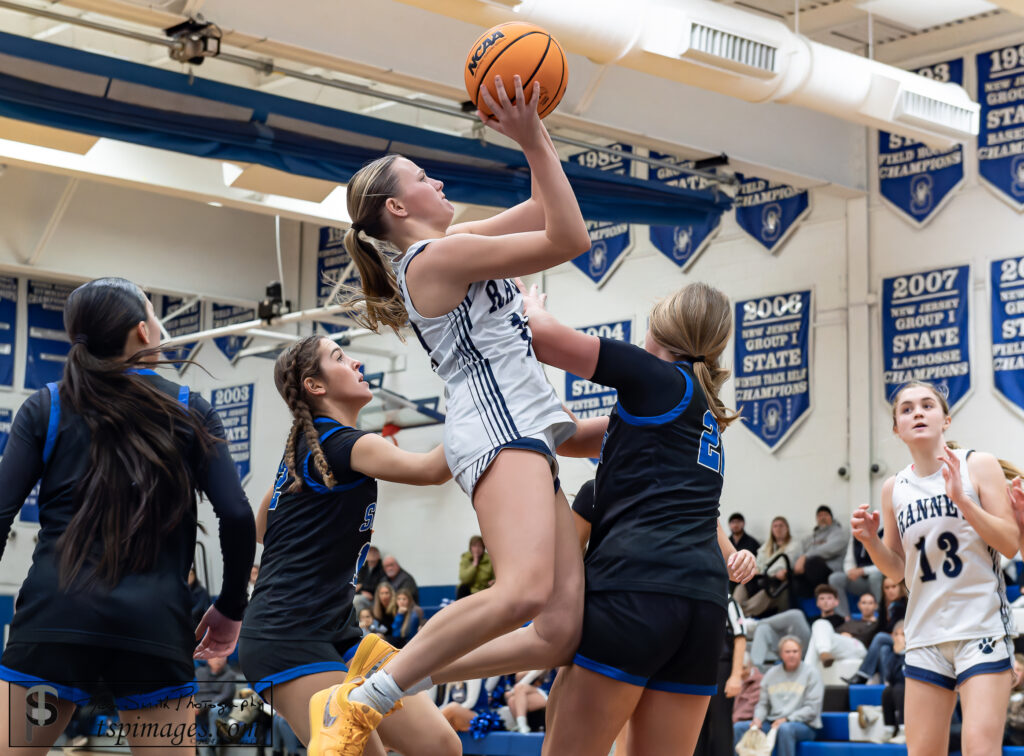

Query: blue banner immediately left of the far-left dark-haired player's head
left=25, top=279, right=75, bottom=389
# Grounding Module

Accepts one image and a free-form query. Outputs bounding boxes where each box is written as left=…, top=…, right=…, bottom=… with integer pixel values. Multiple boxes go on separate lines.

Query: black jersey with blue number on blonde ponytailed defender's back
left=584, top=339, right=728, bottom=606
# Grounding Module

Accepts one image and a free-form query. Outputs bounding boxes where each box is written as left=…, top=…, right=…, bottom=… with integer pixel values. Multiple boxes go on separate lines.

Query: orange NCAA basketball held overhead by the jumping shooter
left=463, top=22, right=569, bottom=118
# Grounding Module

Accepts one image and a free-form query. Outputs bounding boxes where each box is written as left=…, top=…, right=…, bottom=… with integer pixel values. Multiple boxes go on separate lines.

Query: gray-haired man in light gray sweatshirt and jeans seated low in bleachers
left=733, top=635, right=824, bottom=756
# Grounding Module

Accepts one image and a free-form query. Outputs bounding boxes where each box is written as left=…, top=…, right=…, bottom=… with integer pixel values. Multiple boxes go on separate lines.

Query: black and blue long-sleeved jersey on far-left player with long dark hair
left=0, top=370, right=256, bottom=659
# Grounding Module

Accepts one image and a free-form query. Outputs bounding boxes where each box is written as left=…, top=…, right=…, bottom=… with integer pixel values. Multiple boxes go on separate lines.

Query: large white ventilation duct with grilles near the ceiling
left=460, top=0, right=979, bottom=148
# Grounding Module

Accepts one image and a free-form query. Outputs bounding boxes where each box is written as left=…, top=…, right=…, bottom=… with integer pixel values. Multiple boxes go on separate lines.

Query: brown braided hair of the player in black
left=273, top=336, right=335, bottom=494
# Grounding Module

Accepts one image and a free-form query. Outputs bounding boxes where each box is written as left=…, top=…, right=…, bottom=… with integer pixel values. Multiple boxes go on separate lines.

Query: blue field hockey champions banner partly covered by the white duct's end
left=879, top=58, right=964, bottom=227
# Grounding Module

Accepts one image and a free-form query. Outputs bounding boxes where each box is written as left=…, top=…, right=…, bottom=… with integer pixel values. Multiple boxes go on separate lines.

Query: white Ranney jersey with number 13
left=893, top=449, right=1014, bottom=648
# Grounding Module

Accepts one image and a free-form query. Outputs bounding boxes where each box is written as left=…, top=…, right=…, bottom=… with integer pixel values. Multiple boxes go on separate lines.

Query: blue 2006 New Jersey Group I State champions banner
left=734, top=290, right=812, bottom=452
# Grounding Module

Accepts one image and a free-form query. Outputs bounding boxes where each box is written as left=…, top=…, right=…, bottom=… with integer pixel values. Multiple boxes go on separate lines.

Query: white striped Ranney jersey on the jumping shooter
left=395, top=239, right=575, bottom=476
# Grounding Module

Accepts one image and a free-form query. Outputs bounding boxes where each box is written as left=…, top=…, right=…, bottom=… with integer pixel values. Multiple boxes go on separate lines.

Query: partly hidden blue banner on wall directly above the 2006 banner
left=735, top=173, right=811, bottom=254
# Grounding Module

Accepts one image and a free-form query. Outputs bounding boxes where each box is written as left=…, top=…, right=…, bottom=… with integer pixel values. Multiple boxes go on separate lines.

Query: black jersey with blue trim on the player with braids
left=242, top=417, right=377, bottom=641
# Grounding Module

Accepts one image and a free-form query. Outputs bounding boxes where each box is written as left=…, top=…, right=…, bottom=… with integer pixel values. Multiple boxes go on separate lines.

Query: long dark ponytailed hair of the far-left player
left=57, top=278, right=216, bottom=587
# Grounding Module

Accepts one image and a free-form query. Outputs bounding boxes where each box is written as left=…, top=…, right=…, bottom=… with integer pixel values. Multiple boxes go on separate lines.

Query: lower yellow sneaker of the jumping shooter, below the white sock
left=306, top=679, right=383, bottom=756
